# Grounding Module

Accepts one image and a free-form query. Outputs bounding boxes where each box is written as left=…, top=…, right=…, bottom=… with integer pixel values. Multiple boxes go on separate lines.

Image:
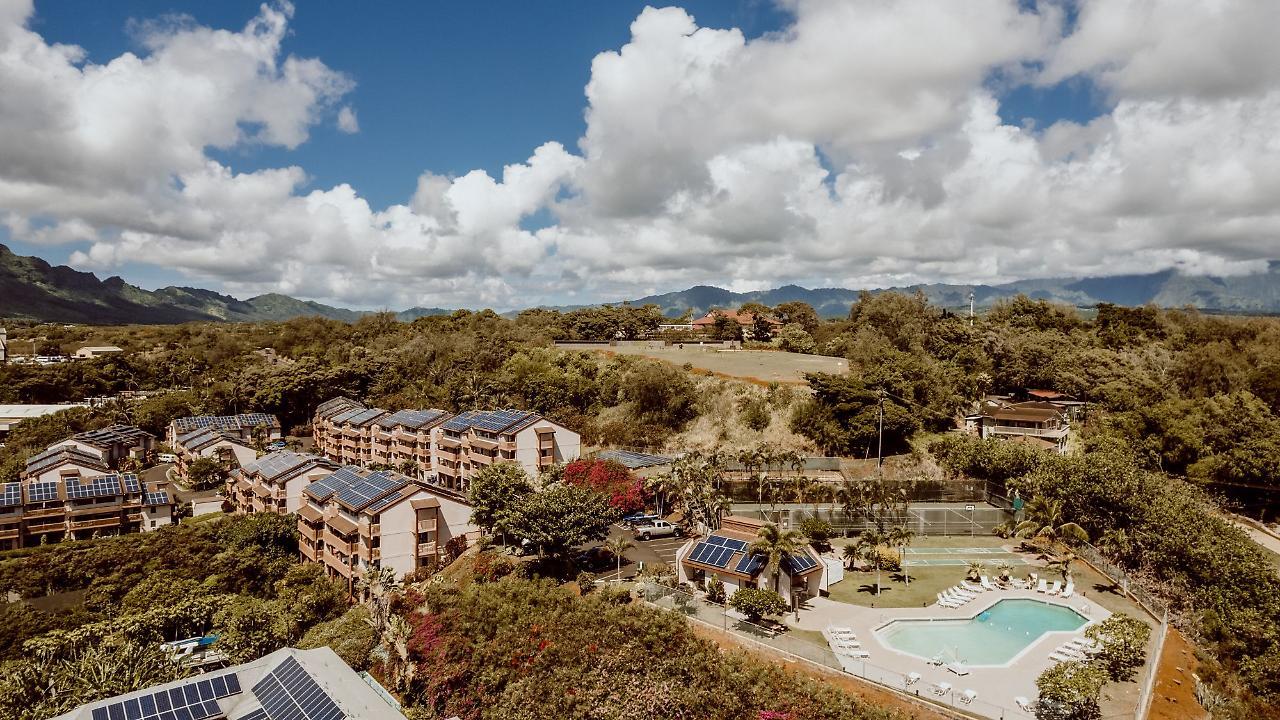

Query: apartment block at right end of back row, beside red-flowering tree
left=435, top=410, right=582, bottom=492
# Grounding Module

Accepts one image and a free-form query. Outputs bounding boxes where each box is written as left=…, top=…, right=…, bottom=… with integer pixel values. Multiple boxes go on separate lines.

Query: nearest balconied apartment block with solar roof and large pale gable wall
left=298, top=465, right=479, bottom=594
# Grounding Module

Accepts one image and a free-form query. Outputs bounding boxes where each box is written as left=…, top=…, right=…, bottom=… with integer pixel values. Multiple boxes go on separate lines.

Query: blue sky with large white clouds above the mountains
left=0, top=0, right=1277, bottom=306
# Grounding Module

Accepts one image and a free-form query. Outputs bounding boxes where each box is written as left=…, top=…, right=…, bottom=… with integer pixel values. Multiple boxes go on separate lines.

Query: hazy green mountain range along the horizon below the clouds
left=0, top=245, right=1280, bottom=324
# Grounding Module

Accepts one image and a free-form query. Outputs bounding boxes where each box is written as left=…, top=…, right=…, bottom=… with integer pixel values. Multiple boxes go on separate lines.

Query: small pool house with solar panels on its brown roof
left=676, top=515, right=827, bottom=607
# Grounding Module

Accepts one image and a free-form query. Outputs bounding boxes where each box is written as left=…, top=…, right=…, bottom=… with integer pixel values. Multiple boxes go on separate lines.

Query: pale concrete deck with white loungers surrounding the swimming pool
left=787, top=589, right=1111, bottom=717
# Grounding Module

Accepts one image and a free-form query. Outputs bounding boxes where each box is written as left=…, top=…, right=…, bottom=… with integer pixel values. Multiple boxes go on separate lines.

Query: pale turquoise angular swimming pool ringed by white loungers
left=876, top=598, right=1088, bottom=665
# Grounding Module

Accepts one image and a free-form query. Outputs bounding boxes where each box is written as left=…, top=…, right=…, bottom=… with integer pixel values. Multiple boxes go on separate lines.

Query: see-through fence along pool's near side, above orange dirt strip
left=637, top=582, right=1034, bottom=720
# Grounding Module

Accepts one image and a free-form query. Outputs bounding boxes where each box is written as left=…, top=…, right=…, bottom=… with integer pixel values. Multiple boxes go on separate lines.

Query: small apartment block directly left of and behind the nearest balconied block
left=225, top=450, right=338, bottom=515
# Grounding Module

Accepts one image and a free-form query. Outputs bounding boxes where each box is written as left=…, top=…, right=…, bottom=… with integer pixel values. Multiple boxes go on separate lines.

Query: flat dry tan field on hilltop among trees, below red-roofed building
left=557, top=343, right=849, bottom=384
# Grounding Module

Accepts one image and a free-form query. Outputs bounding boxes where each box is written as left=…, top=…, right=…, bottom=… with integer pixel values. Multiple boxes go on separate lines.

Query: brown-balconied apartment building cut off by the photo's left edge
left=0, top=445, right=177, bottom=550
